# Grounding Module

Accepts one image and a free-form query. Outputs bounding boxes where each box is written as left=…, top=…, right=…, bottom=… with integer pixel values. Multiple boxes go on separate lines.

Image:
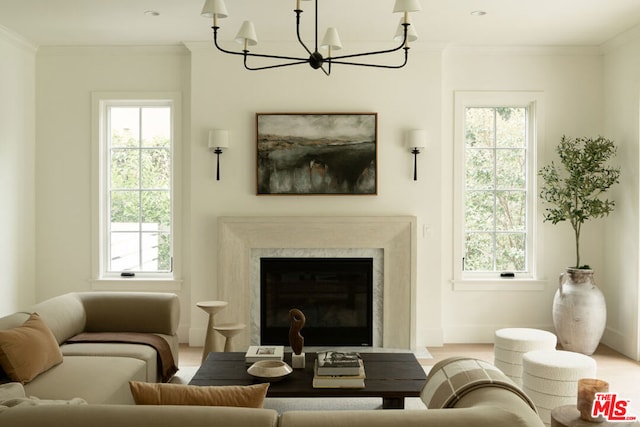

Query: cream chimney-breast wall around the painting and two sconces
left=187, top=43, right=442, bottom=345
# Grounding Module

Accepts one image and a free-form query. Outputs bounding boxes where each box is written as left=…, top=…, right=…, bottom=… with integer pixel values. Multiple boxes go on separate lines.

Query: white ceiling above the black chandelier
left=0, top=0, right=640, bottom=47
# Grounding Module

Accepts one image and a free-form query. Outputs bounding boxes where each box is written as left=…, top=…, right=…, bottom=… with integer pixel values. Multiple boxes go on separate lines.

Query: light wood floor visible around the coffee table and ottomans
left=180, top=344, right=640, bottom=416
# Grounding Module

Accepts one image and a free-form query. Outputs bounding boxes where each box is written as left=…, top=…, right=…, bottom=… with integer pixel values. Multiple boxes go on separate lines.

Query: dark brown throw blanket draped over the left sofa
left=66, top=332, right=178, bottom=383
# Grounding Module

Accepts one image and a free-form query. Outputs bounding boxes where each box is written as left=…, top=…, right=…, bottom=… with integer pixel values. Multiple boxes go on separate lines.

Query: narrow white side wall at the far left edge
left=0, top=27, right=36, bottom=316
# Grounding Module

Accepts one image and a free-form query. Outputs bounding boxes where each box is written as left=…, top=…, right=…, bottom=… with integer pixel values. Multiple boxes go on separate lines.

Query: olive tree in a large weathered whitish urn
left=538, top=136, right=620, bottom=354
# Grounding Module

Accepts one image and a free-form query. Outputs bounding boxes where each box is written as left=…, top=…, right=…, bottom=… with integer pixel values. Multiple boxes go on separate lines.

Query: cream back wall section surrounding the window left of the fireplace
left=36, top=47, right=189, bottom=336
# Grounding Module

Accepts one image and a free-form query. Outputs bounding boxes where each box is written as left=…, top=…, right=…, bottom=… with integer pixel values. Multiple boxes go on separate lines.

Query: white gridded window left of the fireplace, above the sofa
left=91, top=94, right=179, bottom=278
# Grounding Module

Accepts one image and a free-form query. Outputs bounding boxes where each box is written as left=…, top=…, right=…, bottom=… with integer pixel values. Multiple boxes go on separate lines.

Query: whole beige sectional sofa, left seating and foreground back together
left=0, top=293, right=544, bottom=427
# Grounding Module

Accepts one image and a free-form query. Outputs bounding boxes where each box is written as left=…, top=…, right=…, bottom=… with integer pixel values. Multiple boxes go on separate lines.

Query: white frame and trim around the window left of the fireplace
left=92, top=92, right=182, bottom=289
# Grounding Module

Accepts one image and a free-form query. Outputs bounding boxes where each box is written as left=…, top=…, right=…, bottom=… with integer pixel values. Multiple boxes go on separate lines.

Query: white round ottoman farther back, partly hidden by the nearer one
left=493, top=328, right=558, bottom=386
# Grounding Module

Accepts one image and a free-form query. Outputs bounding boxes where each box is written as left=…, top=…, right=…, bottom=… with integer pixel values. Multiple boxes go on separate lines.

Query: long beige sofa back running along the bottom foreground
left=0, top=380, right=544, bottom=427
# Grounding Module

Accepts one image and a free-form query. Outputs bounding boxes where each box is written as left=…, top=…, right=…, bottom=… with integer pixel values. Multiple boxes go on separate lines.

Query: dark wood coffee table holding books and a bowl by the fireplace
left=189, top=353, right=427, bottom=409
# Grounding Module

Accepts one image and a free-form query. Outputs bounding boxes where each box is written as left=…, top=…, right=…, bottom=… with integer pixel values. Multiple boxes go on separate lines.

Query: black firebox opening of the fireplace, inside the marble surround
left=260, top=258, right=373, bottom=346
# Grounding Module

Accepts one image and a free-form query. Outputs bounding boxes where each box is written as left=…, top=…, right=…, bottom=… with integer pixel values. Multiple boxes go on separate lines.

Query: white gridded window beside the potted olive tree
left=454, top=92, right=537, bottom=280
